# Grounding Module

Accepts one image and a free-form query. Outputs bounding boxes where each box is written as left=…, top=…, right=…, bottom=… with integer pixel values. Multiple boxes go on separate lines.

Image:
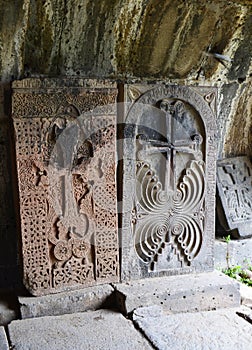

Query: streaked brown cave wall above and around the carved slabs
left=0, top=0, right=252, bottom=285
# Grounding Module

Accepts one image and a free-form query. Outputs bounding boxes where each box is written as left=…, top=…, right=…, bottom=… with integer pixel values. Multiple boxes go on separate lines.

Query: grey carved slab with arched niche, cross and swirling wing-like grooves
left=121, top=84, right=216, bottom=280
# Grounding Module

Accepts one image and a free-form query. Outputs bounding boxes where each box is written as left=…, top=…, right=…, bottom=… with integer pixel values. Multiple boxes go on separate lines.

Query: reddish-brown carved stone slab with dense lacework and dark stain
left=12, top=79, right=119, bottom=295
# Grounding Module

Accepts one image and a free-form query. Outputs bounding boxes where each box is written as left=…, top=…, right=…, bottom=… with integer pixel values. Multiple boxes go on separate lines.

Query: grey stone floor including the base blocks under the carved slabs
left=0, top=234, right=252, bottom=350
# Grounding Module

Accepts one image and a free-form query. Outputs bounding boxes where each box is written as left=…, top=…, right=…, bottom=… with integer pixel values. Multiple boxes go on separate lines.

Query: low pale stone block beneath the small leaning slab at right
left=214, top=237, right=252, bottom=269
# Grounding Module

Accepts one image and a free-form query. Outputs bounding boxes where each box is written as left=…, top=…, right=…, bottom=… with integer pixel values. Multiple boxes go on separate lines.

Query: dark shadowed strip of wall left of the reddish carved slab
left=0, top=85, right=21, bottom=288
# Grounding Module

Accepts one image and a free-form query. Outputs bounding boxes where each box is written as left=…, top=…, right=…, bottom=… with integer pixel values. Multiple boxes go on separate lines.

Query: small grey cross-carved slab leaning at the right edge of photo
left=217, top=157, right=252, bottom=238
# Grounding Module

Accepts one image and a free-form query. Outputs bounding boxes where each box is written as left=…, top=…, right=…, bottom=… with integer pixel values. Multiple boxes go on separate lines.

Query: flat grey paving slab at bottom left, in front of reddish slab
left=8, top=310, right=153, bottom=350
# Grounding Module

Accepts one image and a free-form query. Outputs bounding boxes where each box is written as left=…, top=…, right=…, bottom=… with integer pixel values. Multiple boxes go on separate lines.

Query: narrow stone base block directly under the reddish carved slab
left=18, top=284, right=114, bottom=318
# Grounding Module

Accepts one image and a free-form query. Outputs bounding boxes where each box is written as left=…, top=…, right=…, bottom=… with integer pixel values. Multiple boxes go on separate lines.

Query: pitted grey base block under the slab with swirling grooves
left=115, top=271, right=240, bottom=314
